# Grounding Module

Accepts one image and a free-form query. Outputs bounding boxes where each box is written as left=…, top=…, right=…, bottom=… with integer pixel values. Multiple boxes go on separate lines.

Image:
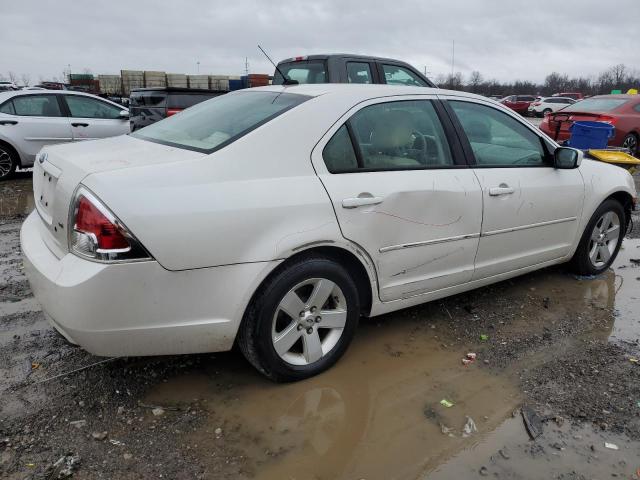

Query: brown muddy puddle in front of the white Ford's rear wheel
left=148, top=320, right=520, bottom=480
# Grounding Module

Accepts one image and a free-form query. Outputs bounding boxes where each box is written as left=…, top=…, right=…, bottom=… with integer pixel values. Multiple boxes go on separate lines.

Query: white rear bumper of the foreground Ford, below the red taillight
left=20, top=212, right=273, bottom=356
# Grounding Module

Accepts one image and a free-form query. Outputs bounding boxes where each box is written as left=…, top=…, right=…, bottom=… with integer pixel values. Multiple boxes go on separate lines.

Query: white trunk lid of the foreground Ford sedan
left=33, top=135, right=204, bottom=258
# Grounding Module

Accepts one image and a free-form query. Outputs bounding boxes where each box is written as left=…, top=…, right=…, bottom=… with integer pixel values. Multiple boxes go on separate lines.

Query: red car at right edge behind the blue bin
left=540, top=95, right=640, bottom=157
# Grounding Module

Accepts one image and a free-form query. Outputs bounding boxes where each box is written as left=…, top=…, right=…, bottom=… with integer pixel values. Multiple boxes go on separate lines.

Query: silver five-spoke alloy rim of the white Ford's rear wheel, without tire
left=271, top=278, right=347, bottom=365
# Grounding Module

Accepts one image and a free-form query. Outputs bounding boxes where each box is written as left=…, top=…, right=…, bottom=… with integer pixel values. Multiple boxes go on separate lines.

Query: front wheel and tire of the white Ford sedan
left=570, top=199, right=627, bottom=275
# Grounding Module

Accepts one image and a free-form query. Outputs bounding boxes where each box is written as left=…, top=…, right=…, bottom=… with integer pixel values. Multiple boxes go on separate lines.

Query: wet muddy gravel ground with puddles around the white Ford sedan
left=0, top=173, right=640, bottom=480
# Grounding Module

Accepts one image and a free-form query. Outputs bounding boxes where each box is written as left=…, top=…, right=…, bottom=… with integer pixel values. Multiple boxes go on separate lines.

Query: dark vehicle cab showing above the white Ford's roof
left=273, top=53, right=435, bottom=87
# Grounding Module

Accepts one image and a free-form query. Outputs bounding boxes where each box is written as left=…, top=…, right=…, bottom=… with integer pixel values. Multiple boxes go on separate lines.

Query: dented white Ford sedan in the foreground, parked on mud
left=21, top=84, right=636, bottom=380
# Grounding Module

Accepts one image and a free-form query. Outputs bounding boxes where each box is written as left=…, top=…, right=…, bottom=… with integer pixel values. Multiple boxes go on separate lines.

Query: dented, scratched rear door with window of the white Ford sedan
left=312, top=99, right=482, bottom=301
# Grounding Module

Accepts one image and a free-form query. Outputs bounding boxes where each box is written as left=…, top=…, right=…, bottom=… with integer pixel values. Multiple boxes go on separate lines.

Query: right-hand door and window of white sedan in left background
left=63, top=94, right=130, bottom=141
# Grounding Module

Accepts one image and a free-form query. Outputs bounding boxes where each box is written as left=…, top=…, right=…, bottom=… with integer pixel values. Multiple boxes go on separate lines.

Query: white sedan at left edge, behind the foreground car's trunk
left=0, top=90, right=130, bottom=180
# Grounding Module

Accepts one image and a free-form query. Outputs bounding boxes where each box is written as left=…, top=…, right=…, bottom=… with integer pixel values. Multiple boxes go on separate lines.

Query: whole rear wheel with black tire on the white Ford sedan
left=238, top=256, right=360, bottom=382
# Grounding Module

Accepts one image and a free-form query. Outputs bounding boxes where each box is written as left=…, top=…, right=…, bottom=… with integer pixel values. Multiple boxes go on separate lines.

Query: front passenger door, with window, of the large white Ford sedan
left=448, top=99, right=584, bottom=279
